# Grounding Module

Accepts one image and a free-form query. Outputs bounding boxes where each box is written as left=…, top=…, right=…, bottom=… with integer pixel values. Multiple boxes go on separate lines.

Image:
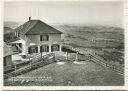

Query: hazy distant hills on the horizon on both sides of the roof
left=4, top=21, right=124, bottom=34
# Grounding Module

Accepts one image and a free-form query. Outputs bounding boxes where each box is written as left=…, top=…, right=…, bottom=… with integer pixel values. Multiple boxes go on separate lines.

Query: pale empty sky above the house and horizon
left=4, top=1, right=123, bottom=27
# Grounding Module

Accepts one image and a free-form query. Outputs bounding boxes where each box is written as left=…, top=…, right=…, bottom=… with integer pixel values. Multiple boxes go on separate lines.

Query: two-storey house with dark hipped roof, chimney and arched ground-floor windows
left=9, top=17, right=62, bottom=55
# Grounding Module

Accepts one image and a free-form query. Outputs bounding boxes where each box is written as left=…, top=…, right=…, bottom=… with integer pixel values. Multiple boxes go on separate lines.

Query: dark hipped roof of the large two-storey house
left=15, top=20, right=62, bottom=34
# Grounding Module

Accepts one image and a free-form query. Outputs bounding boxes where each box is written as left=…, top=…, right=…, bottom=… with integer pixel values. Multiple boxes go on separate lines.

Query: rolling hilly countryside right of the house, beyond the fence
left=53, top=25, right=124, bottom=68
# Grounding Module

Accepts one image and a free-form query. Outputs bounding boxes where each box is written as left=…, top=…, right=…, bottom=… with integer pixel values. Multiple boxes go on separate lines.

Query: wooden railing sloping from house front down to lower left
left=4, top=53, right=55, bottom=78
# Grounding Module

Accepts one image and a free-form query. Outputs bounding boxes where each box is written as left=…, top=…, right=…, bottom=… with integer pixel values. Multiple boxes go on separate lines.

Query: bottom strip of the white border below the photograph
left=0, top=86, right=127, bottom=90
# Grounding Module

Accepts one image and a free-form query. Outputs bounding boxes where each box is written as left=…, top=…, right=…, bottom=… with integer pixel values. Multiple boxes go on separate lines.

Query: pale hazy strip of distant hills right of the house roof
left=54, top=25, right=124, bottom=33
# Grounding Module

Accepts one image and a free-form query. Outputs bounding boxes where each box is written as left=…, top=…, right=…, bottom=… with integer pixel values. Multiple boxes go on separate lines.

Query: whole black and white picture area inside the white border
left=3, top=0, right=125, bottom=86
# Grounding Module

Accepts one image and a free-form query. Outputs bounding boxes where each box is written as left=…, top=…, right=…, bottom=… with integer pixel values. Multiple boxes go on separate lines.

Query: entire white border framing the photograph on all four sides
left=0, top=0, right=128, bottom=90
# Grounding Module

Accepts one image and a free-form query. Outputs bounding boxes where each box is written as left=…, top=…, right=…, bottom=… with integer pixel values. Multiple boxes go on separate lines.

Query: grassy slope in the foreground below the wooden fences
left=5, top=61, right=124, bottom=86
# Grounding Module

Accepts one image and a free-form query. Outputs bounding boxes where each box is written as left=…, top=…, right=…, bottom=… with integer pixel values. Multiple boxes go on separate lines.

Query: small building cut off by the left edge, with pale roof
left=3, top=43, right=13, bottom=72
